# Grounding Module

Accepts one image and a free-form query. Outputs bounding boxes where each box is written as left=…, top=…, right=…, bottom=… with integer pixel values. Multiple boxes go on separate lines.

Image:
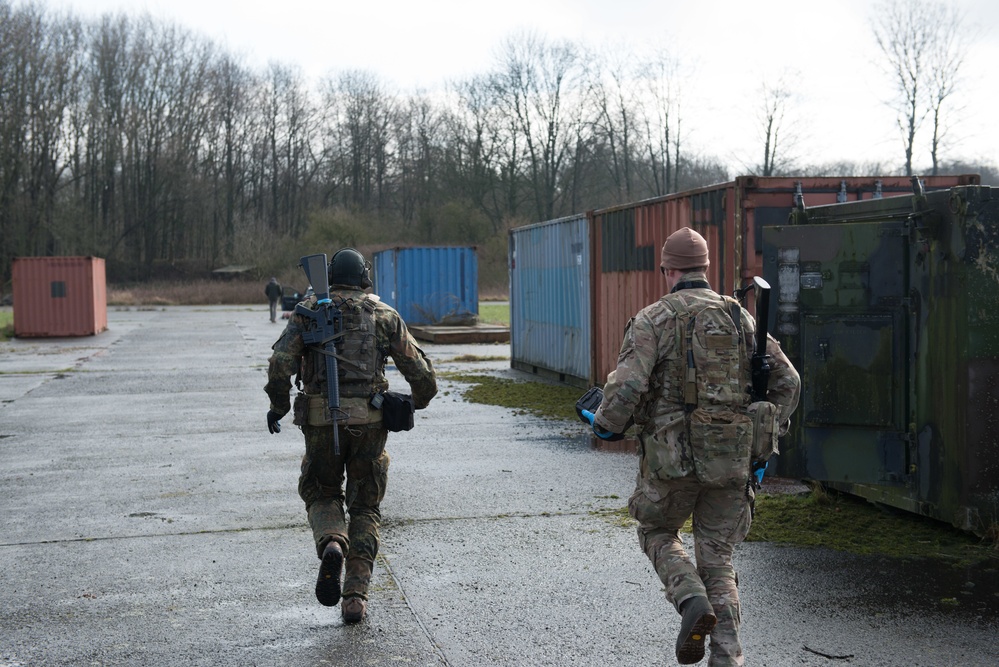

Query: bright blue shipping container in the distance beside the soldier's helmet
left=372, top=246, right=479, bottom=325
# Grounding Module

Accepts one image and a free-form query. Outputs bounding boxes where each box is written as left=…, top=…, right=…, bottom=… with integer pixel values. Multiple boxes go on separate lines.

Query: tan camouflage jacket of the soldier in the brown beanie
left=595, top=272, right=800, bottom=476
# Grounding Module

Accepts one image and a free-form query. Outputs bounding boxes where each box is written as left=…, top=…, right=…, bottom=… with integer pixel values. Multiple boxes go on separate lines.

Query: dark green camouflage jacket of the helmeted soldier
left=264, top=285, right=437, bottom=416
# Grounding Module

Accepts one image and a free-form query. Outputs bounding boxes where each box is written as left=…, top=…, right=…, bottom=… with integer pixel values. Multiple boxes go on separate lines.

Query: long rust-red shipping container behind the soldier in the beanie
left=587, top=175, right=981, bottom=384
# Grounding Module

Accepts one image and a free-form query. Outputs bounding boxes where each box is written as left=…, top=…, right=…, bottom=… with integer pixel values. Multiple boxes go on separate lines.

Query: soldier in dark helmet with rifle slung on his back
left=264, top=248, right=437, bottom=623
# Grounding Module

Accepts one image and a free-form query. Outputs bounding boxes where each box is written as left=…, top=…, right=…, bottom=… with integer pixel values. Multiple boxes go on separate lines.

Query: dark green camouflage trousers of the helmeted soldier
left=298, top=424, right=389, bottom=599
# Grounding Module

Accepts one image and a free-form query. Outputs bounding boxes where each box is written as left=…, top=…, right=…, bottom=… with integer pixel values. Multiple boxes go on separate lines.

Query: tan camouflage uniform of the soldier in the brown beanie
left=595, top=271, right=800, bottom=666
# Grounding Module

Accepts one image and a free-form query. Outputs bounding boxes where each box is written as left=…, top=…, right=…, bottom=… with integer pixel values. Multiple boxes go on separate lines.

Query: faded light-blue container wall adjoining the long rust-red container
left=508, top=215, right=592, bottom=387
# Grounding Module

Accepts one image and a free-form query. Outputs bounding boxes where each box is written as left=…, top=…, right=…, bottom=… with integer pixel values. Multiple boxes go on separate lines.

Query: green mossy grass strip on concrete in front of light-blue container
left=441, top=373, right=580, bottom=420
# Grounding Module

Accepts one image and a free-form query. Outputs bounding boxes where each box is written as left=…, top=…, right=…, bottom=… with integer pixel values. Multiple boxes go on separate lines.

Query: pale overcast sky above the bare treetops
left=40, top=0, right=999, bottom=176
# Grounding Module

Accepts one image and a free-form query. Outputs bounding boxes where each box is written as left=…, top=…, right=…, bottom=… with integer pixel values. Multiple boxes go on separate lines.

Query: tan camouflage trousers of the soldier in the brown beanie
left=628, top=475, right=752, bottom=667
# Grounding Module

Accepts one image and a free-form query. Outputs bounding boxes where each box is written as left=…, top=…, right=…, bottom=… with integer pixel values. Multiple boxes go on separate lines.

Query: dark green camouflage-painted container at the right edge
left=762, top=186, right=999, bottom=534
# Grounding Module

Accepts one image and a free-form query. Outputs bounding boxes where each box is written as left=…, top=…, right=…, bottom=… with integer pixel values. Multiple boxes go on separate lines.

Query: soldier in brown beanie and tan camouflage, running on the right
left=593, top=228, right=800, bottom=667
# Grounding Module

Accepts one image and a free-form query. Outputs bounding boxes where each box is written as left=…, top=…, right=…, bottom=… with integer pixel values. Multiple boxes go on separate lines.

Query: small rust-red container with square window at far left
left=11, top=257, right=108, bottom=338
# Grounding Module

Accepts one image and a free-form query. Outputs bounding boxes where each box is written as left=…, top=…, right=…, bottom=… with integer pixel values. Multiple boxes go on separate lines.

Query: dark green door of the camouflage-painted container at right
left=763, top=222, right=911, bottom=484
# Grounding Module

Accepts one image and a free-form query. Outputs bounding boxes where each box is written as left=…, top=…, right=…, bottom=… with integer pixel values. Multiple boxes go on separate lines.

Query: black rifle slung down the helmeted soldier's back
left=295, top=253, right=343, bottom=456
